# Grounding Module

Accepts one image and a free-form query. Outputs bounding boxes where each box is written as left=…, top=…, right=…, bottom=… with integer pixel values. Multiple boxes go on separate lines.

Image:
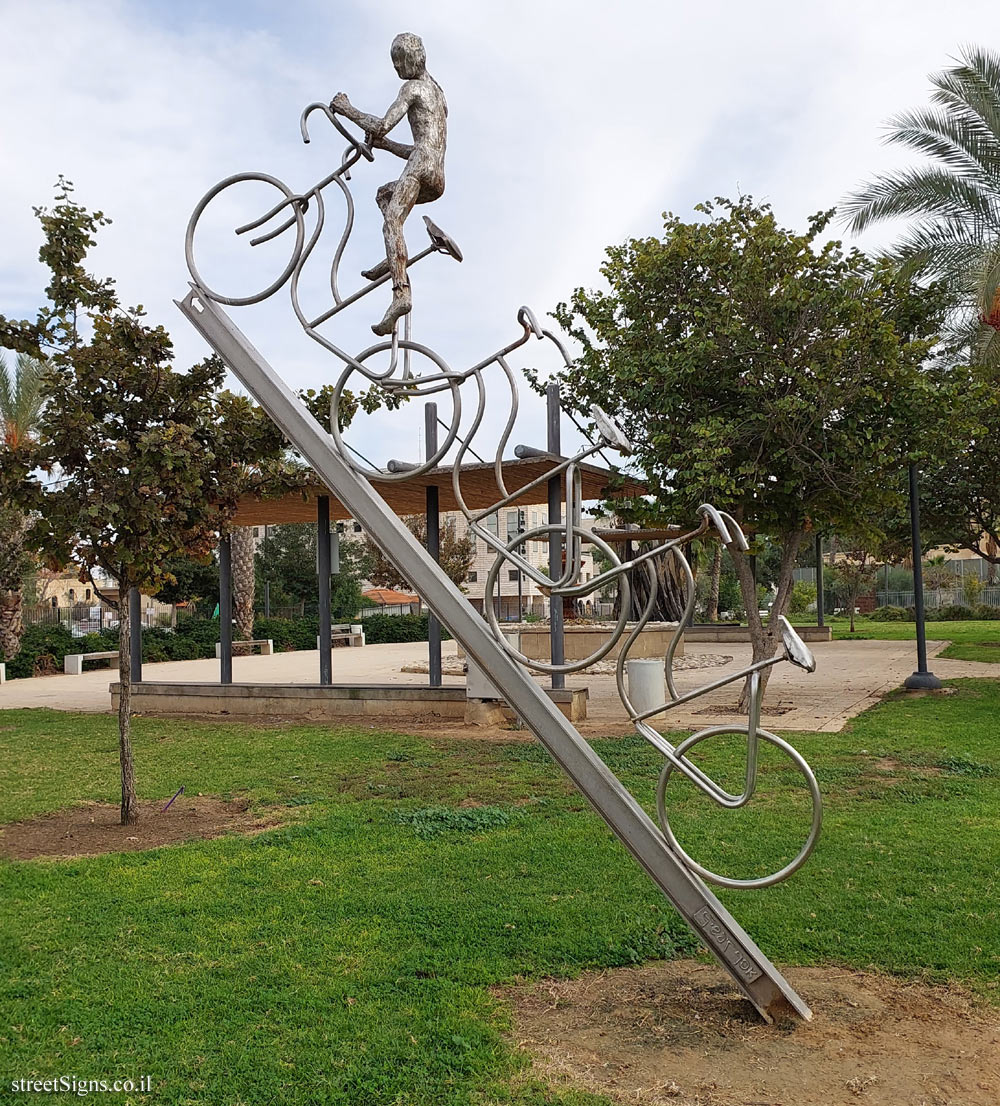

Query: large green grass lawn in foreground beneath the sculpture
left=0, top=676, right=1000, bottom=1106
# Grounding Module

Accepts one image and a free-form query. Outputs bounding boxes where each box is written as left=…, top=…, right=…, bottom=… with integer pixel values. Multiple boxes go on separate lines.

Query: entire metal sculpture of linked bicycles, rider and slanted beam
left=179, top=35, right=821, bottom=1018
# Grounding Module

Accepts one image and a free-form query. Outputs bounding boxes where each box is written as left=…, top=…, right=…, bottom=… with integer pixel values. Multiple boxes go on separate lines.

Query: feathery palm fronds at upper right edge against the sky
left=842, top=46, right=1000, bottom=365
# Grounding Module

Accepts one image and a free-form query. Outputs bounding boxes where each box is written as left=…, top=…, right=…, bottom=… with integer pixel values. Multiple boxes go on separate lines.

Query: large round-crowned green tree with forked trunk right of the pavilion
left=546, top=197, right=940, bottom=706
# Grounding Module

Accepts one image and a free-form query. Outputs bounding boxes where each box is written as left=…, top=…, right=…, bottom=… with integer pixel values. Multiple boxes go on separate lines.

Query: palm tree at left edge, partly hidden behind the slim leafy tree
left=0, top=353, right=45, bottom=660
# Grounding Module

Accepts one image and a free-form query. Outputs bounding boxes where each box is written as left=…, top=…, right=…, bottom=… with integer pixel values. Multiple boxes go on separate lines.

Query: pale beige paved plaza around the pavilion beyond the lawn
left=0, top=641, right=1000, bottom=733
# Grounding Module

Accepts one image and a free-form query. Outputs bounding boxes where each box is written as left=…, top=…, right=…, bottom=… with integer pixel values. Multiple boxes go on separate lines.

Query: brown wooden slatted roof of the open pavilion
left=233, top=456, right=648, bottom=526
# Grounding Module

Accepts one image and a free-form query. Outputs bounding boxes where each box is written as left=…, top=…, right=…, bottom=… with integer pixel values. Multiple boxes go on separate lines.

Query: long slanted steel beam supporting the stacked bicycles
left=175, top=285, right=812, bottom=1022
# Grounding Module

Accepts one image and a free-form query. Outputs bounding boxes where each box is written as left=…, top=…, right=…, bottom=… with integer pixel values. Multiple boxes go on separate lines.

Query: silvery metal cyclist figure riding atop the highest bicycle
left=330, top=34, right=448, bottom=335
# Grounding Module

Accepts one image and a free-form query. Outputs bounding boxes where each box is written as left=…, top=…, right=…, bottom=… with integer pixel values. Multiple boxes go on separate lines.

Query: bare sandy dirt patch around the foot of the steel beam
left=508, top=961, right=1000, bottom=1106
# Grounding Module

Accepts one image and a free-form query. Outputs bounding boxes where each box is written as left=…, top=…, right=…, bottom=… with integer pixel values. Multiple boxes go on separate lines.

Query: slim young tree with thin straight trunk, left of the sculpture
left=0, top=179, right=282, bottom=824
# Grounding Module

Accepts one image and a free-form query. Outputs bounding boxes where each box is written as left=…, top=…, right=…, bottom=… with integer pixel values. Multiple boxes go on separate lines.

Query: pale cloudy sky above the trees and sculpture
left=0, top=0, right=1000, bottom=465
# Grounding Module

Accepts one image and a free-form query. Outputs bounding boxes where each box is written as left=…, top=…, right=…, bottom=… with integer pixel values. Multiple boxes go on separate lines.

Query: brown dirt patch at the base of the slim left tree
left=0, top=795, right=281, bottom=860
